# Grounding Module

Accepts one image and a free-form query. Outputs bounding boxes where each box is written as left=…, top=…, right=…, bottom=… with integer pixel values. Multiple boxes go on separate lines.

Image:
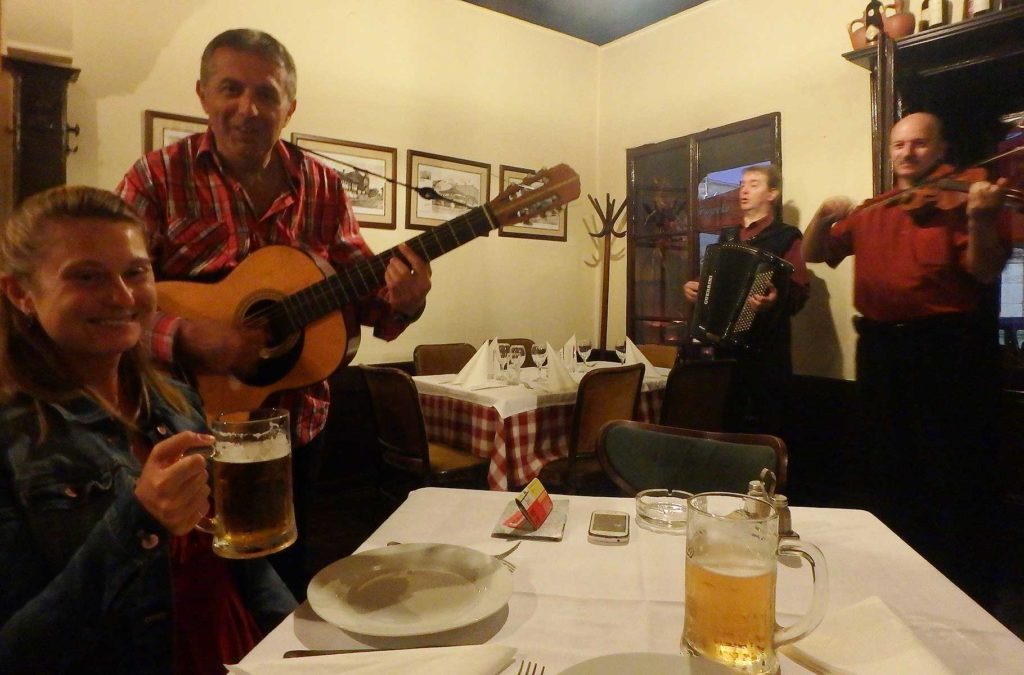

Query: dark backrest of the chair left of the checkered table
left=359, top=366, right=430, bottom=480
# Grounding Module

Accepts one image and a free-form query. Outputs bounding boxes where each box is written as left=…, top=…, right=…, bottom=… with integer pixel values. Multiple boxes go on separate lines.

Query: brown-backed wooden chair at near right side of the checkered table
left=540, top=364, right=644, bottom=495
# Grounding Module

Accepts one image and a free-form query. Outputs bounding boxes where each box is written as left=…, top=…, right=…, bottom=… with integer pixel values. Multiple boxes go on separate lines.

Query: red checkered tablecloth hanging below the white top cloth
left=420, top=387, right=665, bottom=490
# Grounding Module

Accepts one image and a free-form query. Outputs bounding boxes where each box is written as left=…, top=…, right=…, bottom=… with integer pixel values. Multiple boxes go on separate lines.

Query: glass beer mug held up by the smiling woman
left=197, top=409, right=298, bottom=558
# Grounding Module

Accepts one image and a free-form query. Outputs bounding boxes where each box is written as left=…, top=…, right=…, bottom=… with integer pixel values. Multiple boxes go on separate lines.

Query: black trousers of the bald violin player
left=853, top=314, right=999, bottom=592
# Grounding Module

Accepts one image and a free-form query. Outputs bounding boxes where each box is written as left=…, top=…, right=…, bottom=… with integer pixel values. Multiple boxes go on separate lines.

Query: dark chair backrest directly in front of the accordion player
left=658, top=360, right=736, bottom=431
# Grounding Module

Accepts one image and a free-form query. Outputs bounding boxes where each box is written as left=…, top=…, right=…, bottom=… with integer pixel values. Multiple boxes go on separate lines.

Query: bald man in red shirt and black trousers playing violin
left=803, top=113, right=1012, bottom=599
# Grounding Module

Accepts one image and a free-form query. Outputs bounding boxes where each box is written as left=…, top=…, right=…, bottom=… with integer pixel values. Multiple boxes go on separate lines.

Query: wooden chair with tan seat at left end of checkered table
left=359, top=366, right=489, bottom=499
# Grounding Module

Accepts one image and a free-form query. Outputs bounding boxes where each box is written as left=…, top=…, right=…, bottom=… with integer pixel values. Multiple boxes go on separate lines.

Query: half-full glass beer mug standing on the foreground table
left=680, top=493, right=828, bottom=674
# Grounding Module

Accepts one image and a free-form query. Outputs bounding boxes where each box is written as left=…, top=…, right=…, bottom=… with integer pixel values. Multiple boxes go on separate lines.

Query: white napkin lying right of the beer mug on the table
left=780, top=595, right=952, bottom=675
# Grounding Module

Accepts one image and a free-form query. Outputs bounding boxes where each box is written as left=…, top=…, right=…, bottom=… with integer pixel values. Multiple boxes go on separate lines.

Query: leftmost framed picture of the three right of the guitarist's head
left=292, top=133, right=398, bottom=229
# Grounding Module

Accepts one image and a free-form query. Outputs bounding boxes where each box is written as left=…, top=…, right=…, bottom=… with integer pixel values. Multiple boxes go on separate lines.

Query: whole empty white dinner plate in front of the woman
left=307, top=544, right=512, bottom=637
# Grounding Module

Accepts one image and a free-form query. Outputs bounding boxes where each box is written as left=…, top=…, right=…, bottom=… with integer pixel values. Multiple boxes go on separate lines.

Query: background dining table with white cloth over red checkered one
left=413, top=361, right=670, bottom=491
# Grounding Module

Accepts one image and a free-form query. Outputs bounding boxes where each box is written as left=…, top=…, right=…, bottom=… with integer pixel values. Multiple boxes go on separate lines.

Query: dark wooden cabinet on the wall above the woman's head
left=3, top=58, right=79, bottom=204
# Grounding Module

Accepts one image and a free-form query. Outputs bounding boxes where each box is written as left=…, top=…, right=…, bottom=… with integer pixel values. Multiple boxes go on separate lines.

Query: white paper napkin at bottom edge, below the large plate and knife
left=227, top=644, right=515, bottom=675
